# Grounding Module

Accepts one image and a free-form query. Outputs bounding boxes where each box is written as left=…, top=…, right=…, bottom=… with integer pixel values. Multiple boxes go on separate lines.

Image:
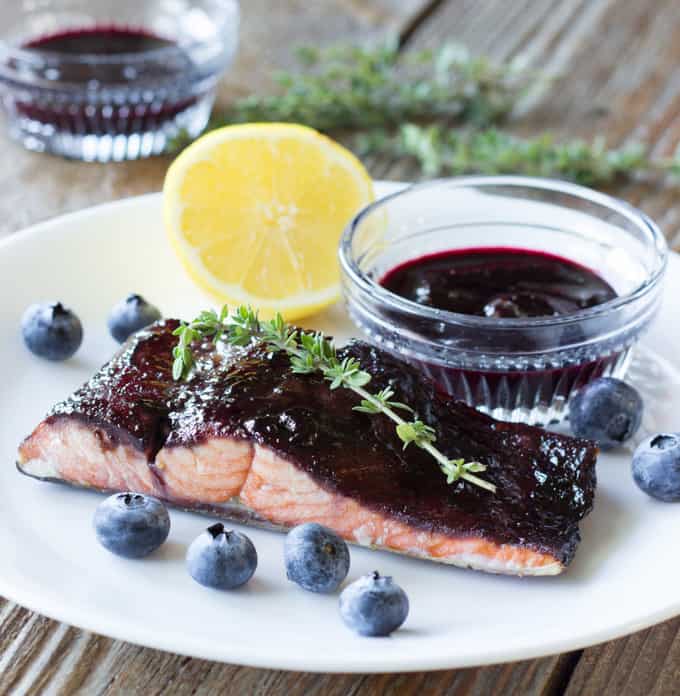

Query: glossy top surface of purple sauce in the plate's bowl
left=381, top=248, right=616, bottom=318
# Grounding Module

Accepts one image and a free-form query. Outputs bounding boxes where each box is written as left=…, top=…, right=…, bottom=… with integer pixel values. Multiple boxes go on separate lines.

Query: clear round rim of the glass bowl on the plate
left=338, top=175, right=668, bottom=331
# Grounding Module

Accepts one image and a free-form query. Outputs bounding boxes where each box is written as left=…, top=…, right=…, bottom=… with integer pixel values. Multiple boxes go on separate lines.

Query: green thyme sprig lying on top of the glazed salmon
left=172, top=306, right=496, bottom=493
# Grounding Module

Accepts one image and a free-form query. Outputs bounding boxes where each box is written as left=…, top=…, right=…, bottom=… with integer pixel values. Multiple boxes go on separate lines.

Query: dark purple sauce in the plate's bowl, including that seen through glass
left=381, top=247, right=621, bottom=420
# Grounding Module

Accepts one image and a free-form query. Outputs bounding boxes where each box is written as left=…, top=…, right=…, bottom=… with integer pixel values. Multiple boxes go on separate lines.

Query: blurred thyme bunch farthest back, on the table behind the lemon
left=165, top=40, right=537, bottom=151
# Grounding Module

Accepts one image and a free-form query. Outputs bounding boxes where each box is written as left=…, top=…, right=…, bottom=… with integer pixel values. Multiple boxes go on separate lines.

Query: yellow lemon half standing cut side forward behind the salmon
left=163, top=123, right=374, bottom=320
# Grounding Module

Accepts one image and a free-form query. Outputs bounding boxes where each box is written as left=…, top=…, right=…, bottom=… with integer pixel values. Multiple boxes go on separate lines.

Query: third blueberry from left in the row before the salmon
left=283, top=522, right=349, bottom=592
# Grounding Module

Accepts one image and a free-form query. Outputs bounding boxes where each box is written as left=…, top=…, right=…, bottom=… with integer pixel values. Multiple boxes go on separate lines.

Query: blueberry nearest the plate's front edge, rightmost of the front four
left=340, top=570, right=409, bottom=636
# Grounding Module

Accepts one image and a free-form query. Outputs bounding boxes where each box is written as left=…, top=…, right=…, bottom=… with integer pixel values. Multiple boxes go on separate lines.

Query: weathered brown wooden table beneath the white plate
left=0, top=0, right=680, bottom=696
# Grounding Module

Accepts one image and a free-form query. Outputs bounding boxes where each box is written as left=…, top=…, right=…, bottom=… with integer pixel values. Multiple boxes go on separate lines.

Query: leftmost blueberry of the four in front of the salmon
left=94, top=493, right=170, bottom=558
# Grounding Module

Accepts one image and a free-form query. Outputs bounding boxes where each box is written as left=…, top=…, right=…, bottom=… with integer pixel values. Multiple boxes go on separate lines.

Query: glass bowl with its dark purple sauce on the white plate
left=340, top=176, right=667, bottom=425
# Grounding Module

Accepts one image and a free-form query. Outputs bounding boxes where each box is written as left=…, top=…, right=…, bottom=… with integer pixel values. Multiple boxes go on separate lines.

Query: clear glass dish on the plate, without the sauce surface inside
left=339, top=176, right=667, bottom=425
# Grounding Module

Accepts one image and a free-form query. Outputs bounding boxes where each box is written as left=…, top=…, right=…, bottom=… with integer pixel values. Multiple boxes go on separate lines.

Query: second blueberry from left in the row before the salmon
left=187, top=522, right=257, bottom=590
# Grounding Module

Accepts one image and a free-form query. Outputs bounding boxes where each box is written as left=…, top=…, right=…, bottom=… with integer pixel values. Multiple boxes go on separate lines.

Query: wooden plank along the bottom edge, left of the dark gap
left=0, top=624, right=568, bottom=696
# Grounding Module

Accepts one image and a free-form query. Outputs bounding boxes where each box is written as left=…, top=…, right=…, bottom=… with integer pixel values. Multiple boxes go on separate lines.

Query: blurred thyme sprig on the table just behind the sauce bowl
left=356, top=124, right=680, bottom=186
